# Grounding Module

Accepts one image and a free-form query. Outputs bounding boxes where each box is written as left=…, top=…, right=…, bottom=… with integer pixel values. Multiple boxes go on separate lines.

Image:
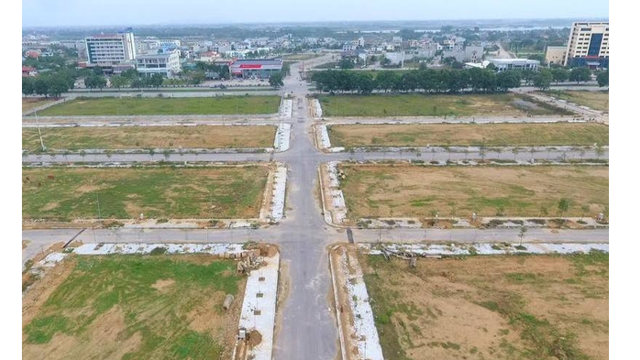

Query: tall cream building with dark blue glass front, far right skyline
left=564, top=22, right=640, bottom=67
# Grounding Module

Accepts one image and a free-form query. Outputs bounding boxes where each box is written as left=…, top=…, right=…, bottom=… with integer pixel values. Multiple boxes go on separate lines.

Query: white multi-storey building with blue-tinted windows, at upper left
left=84, top=28, right=136, bottom=66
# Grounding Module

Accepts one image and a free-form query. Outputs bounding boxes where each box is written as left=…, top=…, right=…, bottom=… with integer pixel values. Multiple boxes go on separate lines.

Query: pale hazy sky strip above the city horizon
left=0, top=0, right=640, bottom=27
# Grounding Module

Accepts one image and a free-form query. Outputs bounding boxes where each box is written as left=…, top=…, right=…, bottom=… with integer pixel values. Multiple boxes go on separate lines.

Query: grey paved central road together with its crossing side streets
left=23, top=56, right=637, bottom=360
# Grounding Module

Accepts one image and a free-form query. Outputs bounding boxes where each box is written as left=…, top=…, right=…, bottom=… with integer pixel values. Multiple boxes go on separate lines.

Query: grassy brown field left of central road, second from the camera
left=22, top=165, right=269, bottom=221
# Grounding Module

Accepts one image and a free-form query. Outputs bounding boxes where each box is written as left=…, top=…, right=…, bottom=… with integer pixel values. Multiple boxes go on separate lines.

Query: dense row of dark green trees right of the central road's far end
left=312, top=68, right=521, bottom=94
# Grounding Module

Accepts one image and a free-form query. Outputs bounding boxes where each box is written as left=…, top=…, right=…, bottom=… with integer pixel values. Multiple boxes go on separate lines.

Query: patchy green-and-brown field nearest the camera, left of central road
left=21, top=254, right=246, bottom=360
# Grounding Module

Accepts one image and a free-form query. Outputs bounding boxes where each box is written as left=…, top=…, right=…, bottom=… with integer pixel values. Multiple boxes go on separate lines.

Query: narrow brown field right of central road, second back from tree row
left=328, top=123, right=611, bottom=147
